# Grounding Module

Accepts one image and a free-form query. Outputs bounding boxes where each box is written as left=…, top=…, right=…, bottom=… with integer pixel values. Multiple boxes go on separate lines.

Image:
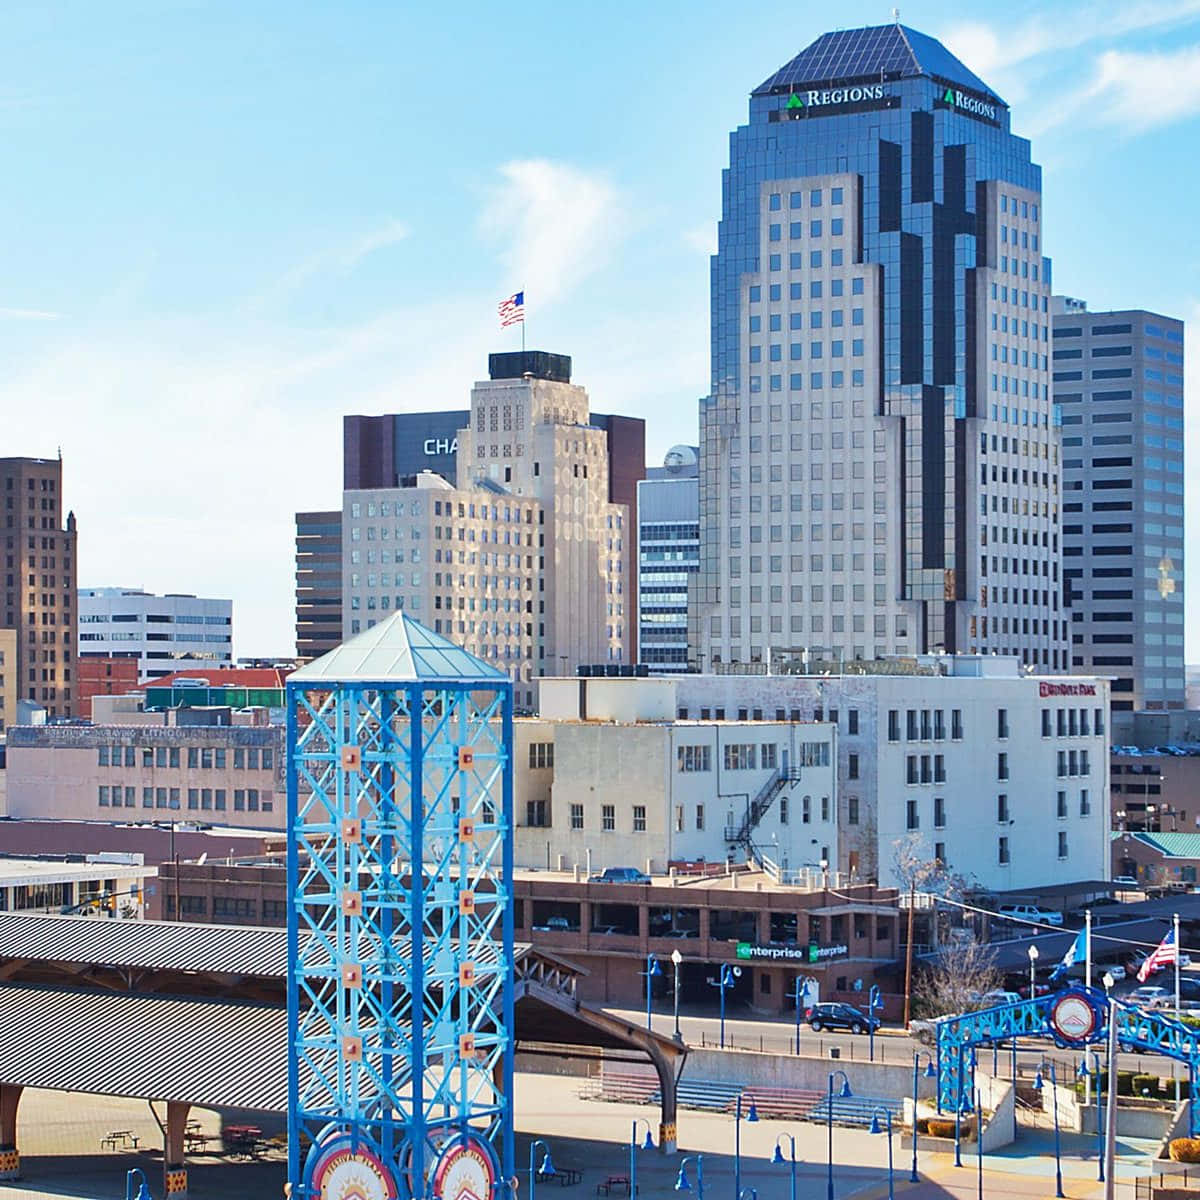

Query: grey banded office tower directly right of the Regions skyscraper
left=1052, top=296, right=1186, bottom=712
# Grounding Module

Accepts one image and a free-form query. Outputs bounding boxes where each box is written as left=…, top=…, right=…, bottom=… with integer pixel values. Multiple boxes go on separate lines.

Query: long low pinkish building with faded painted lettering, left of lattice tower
left=7, top=719, right=287, bottom=830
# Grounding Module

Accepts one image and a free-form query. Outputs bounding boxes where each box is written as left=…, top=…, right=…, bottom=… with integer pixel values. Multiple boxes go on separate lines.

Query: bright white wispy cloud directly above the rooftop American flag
left=479, top=158, right=628, bottom=308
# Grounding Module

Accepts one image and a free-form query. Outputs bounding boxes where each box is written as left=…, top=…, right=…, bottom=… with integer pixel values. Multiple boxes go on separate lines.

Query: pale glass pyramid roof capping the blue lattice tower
left=297, top=612, right=508, bottom=688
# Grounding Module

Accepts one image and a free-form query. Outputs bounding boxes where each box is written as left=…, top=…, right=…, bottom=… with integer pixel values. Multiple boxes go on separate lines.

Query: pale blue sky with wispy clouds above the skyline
left=0, top=0, right=1200, bottom=660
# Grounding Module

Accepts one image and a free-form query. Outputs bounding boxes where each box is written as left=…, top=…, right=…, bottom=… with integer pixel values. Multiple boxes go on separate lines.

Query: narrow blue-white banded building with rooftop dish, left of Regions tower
left=637, top=445, right=700, bottom=671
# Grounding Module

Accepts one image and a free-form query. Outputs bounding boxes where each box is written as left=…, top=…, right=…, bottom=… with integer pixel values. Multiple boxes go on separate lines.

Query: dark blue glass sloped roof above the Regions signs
left=752, top=24, right=1004, bottom=104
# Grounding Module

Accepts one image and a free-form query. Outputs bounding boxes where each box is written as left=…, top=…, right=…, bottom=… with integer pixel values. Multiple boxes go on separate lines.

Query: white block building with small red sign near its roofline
left=541, top=655, right=1110, bottom=890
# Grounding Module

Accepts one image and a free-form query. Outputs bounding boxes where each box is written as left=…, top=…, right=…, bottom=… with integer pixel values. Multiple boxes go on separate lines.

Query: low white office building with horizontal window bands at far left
left=79, top=588, right=233, bottom=683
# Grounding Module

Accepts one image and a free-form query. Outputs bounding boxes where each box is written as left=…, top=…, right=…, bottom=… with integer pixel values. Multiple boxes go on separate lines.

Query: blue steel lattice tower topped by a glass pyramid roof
left=287, top=613, right=514, bottom=1200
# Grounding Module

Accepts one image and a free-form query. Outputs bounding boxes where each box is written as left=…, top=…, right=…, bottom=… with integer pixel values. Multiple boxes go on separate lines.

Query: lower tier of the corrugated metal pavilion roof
left=0, top=984, right=288, bottom=1112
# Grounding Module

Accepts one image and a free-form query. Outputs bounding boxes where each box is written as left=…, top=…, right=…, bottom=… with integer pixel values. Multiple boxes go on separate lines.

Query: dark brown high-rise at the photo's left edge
left=0, top=458, right=76, bottom=710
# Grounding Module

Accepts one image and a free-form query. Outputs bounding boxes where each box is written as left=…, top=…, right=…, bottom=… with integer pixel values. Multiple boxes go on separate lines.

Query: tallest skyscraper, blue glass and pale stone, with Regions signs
left=689, top=24, right=1068, bottom=671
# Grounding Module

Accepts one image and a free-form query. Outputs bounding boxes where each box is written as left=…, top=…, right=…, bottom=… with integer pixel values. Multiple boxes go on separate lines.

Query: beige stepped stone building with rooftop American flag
left=342, top=350, right=644, bottom=709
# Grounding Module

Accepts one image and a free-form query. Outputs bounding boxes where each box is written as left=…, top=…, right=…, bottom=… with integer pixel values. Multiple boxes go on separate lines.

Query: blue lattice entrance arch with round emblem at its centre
left=936, top=986, right=1200, bottom=1138
